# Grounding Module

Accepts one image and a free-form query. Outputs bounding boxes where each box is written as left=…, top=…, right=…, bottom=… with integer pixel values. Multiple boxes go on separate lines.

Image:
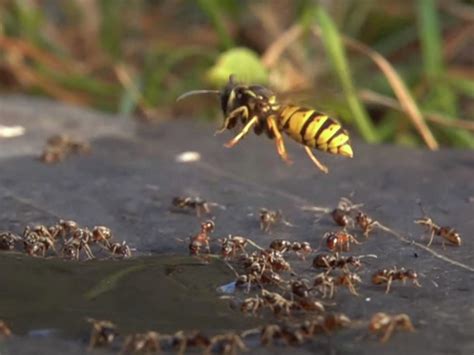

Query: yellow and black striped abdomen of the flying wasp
left=278, top=105, right=353, bottom=158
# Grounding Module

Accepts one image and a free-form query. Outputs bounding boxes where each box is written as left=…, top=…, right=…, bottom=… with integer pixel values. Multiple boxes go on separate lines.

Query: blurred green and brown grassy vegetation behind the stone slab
left=0, top=0, right=474, bottom=149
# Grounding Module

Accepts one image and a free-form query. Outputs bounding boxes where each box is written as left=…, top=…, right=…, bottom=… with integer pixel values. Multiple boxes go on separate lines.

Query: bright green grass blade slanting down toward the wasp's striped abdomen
left=316, top=6, right=379, bottom=143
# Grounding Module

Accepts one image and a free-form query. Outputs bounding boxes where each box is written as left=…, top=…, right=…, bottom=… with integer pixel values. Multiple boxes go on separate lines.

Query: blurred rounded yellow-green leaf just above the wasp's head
left=206, top=47, right=268, bottom=87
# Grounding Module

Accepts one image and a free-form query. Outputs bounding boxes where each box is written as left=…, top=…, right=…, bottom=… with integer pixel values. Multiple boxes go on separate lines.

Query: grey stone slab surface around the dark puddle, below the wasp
left=0, top=97, right=474, bottom=354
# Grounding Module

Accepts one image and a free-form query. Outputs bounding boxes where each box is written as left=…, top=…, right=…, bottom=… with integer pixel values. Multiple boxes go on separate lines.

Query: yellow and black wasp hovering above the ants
left=178, top=75, right=353, bottom=173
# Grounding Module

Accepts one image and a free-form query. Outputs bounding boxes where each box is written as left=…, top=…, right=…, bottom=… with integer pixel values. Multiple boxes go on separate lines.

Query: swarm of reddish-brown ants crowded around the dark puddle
left=0, top=197, right=461, bottom=354
